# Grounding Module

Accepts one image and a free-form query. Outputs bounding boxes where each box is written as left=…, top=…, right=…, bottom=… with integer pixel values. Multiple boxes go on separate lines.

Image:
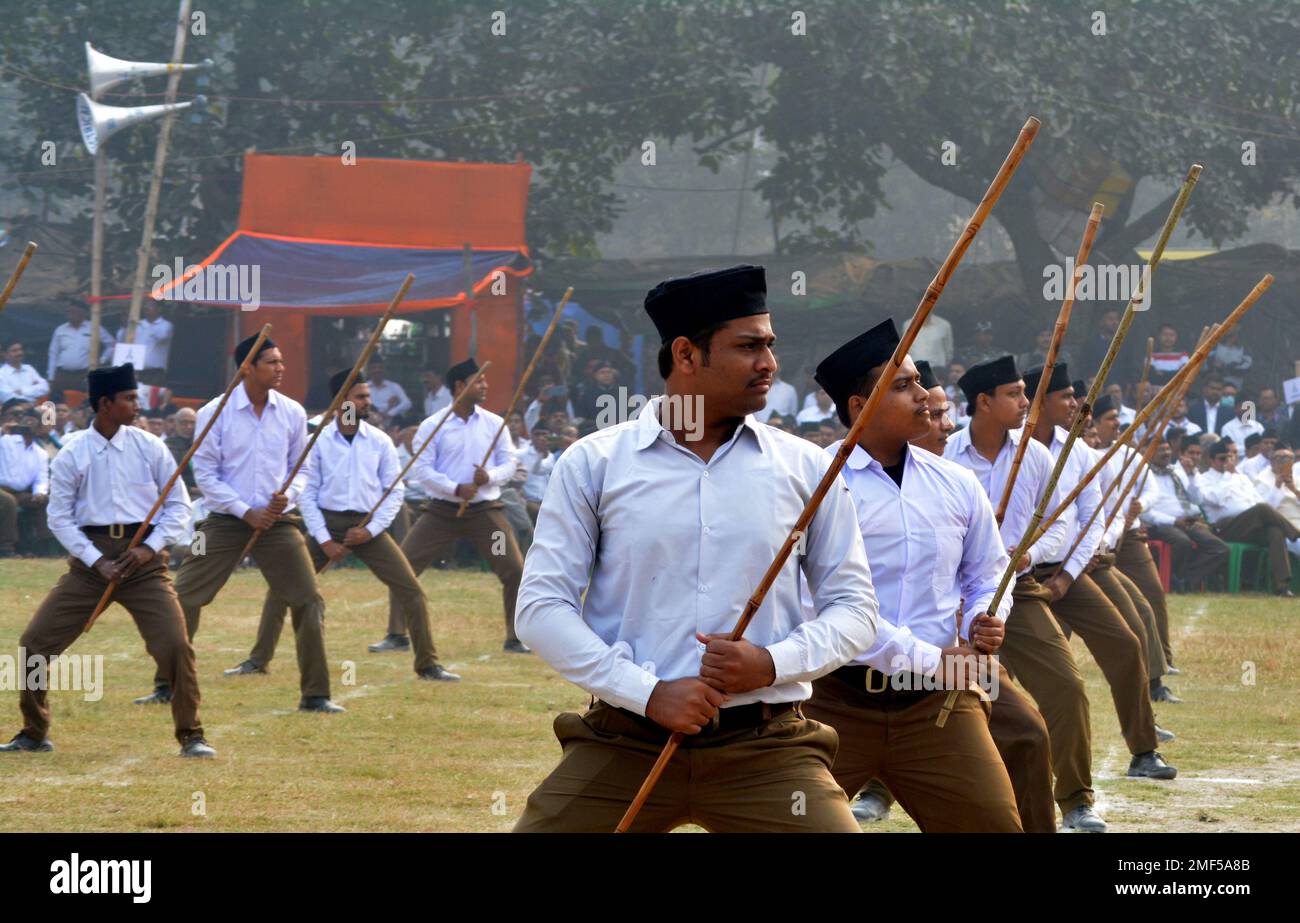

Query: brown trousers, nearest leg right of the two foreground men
left=993, top=575, right=1093, bottom=811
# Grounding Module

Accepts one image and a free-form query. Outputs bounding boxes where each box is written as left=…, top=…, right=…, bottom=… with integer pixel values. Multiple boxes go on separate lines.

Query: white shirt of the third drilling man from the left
left=299, top=420, right=406, bottom=545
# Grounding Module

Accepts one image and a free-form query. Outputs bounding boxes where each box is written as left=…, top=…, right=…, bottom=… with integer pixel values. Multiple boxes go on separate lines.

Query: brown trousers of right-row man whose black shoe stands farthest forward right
left=1035, top=564, right=1156, bottom=754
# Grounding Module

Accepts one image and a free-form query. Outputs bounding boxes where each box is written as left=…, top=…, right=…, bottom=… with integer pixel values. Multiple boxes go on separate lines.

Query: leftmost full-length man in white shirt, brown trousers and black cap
left=0, top=363, right=216, bottom=757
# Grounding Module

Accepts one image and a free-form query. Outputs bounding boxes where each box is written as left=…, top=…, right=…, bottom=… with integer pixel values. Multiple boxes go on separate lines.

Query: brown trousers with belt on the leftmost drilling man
left=18, top=533, right=203, bottom=745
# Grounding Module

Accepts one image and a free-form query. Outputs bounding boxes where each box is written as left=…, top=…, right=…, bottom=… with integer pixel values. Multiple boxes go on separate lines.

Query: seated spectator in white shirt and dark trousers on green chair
left=1196, top=439, right=1300, bottom=597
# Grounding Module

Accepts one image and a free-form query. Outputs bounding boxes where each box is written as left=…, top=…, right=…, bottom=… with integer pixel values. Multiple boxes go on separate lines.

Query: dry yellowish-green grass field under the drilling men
left=0, top=560, right=1300, bottom=832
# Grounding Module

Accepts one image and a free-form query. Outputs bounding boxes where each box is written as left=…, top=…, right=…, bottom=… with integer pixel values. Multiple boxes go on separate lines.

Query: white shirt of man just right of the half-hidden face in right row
left=944, top=428, right=1069, bottom=573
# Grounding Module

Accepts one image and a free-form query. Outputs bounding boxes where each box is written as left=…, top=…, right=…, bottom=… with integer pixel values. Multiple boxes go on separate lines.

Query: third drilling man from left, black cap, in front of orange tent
left=225, top=369, right=460, bottom=683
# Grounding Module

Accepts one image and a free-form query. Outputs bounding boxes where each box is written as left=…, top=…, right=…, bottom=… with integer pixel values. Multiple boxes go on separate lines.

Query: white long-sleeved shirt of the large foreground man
left=515, top=398, right=879, bottom=715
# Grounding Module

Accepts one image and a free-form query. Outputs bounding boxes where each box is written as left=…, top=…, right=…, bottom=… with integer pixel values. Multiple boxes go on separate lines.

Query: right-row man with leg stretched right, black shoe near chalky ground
left=1024, top=364, right=1178, bottom=779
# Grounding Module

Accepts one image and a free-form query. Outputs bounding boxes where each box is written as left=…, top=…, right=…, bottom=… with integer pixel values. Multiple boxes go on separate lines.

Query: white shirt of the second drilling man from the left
left=191, top=382, right=307, bottom=519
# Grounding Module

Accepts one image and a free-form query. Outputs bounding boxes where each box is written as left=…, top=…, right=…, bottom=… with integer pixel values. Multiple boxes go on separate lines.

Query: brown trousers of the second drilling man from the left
left=170, top=512, right=329, bottom=698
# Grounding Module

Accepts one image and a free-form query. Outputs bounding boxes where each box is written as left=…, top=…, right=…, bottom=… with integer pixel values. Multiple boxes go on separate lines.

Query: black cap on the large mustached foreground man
left=645, top=265, right=768, bottom=343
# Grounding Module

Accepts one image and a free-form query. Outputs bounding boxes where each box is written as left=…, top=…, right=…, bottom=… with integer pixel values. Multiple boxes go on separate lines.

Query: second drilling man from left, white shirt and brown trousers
left=157, top=337, right=343, bottom=712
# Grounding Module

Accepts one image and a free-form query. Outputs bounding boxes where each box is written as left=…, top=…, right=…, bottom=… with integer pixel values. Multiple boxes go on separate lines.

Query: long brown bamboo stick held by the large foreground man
left=615, top=117, right=1040, bottom=833
